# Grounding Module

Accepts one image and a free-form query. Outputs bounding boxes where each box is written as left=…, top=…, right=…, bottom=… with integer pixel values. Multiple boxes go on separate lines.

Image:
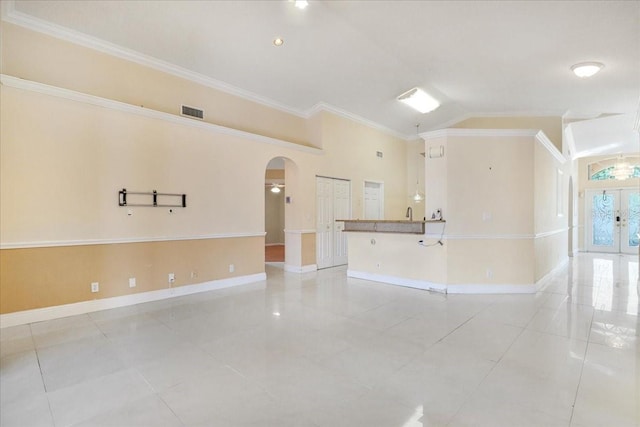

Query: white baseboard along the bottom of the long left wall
left=0, top=273, right=267, bottom=328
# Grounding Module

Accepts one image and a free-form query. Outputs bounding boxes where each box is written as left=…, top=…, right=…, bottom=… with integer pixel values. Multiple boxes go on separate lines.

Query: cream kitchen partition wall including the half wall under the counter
left=349, top=129, right=568, bottom=293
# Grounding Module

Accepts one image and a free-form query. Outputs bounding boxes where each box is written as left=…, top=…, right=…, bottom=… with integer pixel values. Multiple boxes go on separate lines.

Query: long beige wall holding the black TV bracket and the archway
left=0, top=23, right=408, bottom=314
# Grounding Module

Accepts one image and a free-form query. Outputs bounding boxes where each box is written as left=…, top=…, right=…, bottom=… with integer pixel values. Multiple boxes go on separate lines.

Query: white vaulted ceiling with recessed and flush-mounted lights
left=5, top=0, right=640, bottom=154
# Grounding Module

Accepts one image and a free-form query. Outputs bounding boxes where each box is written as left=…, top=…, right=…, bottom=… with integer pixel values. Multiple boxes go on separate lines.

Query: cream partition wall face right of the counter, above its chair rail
left=444, top=136, right=535, bottom=235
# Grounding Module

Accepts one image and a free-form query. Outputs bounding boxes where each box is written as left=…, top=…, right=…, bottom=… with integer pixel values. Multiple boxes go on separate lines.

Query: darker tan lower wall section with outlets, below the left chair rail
left=0, top=237, right=264, bottom=314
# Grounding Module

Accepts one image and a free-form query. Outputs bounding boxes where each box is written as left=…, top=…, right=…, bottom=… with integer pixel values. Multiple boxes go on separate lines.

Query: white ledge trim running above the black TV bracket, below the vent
left=0, top=74, right=323, bottom=154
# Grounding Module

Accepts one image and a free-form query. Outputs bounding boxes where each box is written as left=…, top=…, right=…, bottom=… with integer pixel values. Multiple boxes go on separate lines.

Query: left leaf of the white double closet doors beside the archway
left=316, top=177, right=334, bottom=268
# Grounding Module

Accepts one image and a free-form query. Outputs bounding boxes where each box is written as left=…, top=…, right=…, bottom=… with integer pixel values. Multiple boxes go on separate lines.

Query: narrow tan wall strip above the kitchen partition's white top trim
left=451, top=116, right=562, bottom=153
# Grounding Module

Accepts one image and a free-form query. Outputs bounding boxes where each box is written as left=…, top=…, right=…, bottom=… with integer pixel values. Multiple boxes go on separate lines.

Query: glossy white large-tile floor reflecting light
left=0, top=254, right=640, bottom=427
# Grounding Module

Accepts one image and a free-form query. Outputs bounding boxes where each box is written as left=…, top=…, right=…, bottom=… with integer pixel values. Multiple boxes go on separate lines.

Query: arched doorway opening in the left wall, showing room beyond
left=264, top=157, right=286, bottom=265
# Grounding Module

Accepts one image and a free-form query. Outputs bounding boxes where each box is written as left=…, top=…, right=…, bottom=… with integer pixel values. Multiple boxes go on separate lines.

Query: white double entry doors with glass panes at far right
left=586, top=189, right=640, bottom=254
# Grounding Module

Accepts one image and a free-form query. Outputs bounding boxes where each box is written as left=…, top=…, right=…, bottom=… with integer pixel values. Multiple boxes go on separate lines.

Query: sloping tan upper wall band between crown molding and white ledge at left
left=1, top=22, right=309, bottom=145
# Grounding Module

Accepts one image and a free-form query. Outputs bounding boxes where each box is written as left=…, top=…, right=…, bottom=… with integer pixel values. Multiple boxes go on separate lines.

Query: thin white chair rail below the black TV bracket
left=0, top=232, right=267, bottom=249
